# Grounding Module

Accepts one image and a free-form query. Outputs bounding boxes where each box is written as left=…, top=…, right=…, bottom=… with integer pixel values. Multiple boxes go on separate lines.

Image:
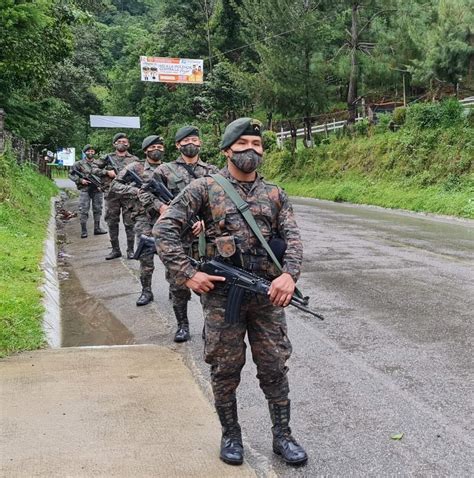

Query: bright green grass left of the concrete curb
left=0, top=152, right=57, bottom=356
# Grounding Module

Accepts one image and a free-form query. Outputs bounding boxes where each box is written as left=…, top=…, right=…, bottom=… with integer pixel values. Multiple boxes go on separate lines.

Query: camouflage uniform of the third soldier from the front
left=112, top=160, right=161, bottom=300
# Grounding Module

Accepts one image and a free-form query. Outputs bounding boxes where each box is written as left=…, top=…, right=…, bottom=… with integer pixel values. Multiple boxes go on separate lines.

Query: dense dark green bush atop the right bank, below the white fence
left=406, top=98, right=463, bottom=129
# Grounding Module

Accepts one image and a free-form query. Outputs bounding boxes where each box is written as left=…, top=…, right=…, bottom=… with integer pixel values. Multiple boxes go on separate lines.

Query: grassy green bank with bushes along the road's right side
left=263, top=101, right=474, bottom=218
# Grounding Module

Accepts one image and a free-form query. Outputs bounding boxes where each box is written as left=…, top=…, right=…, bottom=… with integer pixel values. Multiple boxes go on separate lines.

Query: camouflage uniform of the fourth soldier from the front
left=94, top=152, right=138, bottom=253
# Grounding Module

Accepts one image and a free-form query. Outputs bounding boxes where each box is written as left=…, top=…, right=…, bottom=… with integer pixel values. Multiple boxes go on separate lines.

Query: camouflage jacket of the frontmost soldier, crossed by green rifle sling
left=153, top=168, right=303, bottom=284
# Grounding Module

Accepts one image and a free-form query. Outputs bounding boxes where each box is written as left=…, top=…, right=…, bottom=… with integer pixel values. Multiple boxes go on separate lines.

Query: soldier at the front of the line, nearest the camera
left=153, top=118, right=307, bottom=465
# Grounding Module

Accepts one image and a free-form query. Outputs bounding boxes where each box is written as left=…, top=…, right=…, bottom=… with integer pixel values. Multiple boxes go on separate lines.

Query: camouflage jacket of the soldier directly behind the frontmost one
left=151, top=156, right=219, bottom=209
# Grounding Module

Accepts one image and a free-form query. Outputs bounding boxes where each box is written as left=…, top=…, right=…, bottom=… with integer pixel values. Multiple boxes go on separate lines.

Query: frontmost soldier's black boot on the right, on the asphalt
left=268, top=400, right=308, bottom=466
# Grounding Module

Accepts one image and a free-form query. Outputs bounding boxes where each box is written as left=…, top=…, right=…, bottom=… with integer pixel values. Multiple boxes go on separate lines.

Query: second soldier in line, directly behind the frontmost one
left=155, top=126, right=218, bottom=342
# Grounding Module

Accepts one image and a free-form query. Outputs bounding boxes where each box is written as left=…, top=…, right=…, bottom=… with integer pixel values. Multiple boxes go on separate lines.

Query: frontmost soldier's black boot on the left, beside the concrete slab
left=216, top=400, right=244, bottom=465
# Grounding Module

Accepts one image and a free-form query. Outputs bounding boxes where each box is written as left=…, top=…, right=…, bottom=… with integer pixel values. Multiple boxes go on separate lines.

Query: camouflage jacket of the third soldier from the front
left=110, top=159, right=162, bottom=222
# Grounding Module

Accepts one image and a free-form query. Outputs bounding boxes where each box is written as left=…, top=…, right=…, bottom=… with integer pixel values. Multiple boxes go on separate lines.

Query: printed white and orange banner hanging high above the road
left=140, top=56, right=204, bottom=84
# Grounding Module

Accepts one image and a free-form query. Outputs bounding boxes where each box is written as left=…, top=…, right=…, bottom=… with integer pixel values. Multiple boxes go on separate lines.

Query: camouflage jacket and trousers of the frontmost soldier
left=154, top=168, right=302, bottom=398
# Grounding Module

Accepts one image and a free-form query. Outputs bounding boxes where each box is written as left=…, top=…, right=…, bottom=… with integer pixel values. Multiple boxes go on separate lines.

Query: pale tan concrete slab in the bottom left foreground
left=0, top=345, right=255, bottom=477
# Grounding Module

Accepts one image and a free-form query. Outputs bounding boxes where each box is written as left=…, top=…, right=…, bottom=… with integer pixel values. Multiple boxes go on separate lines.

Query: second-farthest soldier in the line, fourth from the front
left=94, top=133, right=138, bottom=261
